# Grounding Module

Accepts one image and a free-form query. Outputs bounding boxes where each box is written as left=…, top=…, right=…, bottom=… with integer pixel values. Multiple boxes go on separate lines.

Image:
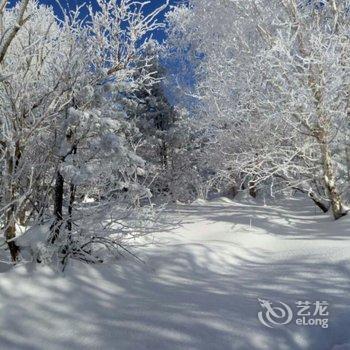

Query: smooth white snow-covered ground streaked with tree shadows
left=0, top=199, right=350, bottom=350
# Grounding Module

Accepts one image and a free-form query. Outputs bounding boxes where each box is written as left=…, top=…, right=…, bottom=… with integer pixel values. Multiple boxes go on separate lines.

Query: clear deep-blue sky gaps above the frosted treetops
left=10, top=0, right=186, bottom=41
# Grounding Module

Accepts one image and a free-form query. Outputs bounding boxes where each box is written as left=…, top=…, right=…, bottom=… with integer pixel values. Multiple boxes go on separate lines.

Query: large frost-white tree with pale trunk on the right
left=168, top=0, right=350, bottom=219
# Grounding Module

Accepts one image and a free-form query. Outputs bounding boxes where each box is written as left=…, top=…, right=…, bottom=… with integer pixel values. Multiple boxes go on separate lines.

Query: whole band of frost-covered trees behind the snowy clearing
left=0, top=0, right=350, bottom=265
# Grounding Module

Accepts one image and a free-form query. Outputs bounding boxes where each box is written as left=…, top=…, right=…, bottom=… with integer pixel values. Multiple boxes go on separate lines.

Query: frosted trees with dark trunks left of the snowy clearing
left=0, top=0, right=167, bottom=260
